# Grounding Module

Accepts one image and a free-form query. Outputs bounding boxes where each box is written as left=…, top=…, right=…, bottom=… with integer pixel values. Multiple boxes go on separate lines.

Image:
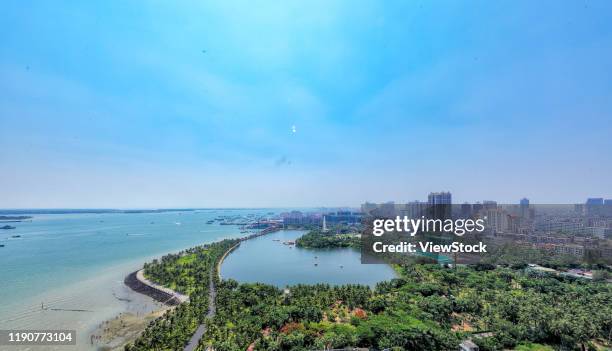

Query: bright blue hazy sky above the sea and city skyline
left=0, top=0, right=612, bottom=208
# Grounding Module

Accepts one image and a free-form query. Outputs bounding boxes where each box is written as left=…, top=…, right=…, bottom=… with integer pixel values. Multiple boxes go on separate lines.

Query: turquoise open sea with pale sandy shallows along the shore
left=0, top=210, right=256, bottom=349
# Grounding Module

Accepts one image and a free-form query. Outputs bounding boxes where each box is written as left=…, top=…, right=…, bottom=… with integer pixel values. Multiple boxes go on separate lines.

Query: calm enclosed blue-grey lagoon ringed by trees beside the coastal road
left=221, top=231, right=395, bottom=287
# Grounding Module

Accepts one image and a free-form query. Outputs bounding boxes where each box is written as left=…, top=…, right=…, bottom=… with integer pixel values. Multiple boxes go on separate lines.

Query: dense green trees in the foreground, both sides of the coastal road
left=128, top=234, right=612, bottom=351
